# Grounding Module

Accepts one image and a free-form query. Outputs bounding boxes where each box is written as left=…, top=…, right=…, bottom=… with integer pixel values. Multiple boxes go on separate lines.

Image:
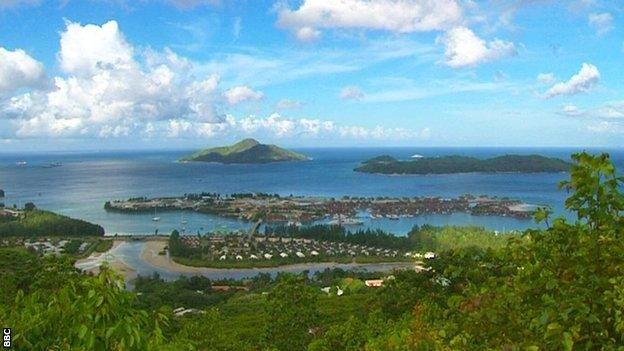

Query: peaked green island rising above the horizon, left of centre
left=180, top=139, right=309, bottom=163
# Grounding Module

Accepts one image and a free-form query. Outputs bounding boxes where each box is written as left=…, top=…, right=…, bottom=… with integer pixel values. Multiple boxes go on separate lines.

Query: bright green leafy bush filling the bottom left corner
left=0, top=263, right=167, bottom=350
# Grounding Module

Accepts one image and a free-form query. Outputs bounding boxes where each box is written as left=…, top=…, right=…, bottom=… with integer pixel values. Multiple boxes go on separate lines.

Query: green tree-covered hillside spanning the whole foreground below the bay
left=0, top=153, right=624, bottom=351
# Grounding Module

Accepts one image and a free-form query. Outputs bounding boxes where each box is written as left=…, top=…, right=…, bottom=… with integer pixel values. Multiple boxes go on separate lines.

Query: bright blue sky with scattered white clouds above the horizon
left=0, top=0, right=624, bottom=152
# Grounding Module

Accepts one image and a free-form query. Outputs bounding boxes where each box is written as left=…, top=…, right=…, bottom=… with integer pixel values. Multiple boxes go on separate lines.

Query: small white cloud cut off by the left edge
left=0, top=47, right=45, bottom=95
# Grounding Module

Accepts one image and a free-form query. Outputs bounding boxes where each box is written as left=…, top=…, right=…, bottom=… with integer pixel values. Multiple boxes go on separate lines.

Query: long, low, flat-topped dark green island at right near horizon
left=355, top=155, right=570, bottom=174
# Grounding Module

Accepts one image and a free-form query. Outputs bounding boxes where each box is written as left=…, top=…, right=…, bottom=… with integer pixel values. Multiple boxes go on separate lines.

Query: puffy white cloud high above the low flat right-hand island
left=438, top=26, right=517, bottom=67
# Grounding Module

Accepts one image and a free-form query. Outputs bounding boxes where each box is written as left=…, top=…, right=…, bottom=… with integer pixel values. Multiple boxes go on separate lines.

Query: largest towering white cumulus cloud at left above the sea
left=2, top=21, right=220, bottom=137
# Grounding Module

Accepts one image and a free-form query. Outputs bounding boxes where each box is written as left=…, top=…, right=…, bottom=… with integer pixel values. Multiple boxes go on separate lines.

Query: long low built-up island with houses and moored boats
left=104, top=192, right=536, bottom=221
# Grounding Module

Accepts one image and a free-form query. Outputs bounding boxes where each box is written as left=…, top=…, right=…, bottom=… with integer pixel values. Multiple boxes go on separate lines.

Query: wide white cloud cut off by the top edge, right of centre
left=278, top=0, right=462, bottom=40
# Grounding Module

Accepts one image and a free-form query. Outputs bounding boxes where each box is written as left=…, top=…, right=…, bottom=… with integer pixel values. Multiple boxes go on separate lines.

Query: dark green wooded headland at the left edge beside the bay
left=0, top=205, right=104, bottom=237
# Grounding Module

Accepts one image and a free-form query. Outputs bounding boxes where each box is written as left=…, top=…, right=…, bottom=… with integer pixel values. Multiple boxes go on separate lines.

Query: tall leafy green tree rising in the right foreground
left=408, top=153, right=624, bottom=350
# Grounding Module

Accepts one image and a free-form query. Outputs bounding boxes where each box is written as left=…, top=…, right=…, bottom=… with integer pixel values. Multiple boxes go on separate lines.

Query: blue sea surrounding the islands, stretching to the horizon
left=0, top=147, right=624, bottom=235
